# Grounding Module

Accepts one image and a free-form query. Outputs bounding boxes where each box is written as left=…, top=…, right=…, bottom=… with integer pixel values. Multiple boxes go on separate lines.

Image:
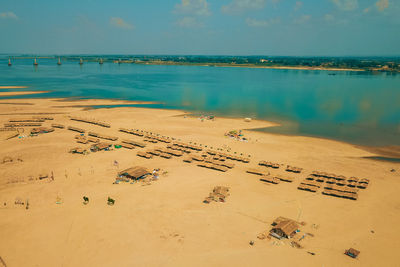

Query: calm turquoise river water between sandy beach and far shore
left=0, top=59, right=400, bottom=148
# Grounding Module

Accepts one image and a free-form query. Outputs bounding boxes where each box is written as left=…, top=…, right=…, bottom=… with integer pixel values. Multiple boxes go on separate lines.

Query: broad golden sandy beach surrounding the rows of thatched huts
left=0, top=99, right=400, bottom=267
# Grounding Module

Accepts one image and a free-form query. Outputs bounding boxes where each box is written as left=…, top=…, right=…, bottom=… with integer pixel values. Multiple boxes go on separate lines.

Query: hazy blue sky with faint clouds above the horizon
left=0, top=0, right=400, bottom=56
